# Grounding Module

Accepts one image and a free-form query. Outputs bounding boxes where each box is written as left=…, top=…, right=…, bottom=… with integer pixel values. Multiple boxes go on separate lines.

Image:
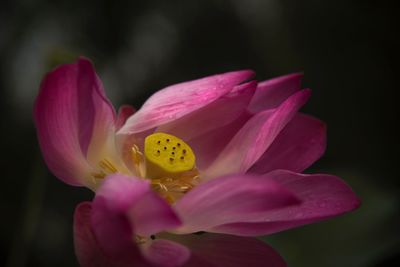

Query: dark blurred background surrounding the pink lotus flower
left=0, top=0, right=400, bottom=267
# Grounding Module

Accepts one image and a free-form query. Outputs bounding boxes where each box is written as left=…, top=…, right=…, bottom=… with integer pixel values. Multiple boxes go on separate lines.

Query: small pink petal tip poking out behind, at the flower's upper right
left=249, top=73, right=303, bottom=113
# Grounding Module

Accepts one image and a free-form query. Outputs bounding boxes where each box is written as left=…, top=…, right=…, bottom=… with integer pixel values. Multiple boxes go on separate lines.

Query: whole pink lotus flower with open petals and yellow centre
left=34, top=59, right=359, bottom=266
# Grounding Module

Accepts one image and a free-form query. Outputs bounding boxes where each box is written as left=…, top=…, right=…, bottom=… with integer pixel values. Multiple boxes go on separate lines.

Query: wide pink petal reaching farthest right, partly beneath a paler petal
left=211, top=170, right=360, bottom=236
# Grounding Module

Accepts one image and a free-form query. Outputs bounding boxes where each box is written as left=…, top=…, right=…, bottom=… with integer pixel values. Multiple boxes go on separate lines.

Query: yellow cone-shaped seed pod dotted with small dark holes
left=144, top=133, right=196, bottom=178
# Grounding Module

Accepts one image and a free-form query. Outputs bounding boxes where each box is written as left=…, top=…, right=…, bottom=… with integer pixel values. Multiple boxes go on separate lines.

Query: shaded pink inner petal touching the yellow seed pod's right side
left=188, top=111, right=252, bottom=173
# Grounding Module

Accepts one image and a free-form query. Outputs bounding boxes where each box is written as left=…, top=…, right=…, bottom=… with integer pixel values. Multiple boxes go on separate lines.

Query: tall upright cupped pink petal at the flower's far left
left=34, top=58, right=114, bottom=185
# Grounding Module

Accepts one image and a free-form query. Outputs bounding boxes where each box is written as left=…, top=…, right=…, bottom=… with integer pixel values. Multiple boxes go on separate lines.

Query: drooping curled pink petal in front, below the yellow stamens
left=91, top=174, right=180, bottom=262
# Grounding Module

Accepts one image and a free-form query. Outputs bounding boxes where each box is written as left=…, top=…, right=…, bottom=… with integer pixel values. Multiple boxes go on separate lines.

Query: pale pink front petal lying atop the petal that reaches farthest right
left=174, top=174, right=298, bottom=234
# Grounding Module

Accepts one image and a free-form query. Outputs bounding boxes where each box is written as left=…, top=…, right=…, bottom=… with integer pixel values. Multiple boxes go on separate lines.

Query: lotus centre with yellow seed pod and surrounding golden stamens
left=92, top=132, right=200, bottom=204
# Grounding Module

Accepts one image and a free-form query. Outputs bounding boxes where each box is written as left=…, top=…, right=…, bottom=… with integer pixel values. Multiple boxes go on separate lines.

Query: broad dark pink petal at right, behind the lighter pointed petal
left=252, top=114, right=326, bottom=174
